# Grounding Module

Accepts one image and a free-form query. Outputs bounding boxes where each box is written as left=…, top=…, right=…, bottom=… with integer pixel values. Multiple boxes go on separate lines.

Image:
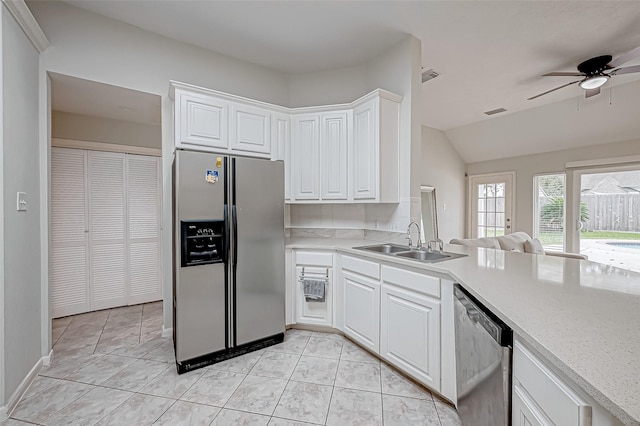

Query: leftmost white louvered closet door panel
left=49, top=148, right=89, bottom=318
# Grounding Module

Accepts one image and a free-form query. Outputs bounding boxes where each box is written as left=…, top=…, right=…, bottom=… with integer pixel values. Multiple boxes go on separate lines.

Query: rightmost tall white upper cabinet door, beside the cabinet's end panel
left=352, top=99, right=380, bottom=200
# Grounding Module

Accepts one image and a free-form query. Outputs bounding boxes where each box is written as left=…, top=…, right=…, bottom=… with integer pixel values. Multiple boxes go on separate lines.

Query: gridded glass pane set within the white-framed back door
left=477, top=182, right=506, bottom=238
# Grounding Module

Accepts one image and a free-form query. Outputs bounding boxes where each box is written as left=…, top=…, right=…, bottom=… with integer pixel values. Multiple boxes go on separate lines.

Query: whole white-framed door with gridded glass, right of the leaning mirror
left=469, top=172, right=514, bottom=238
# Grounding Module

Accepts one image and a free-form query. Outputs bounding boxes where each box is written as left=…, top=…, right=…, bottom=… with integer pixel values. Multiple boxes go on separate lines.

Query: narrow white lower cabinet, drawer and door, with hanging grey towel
left=294, top=251, right=333, bottom=327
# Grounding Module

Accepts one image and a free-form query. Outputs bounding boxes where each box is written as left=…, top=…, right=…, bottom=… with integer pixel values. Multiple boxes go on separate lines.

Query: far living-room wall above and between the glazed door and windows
left=464, top=140, right=640, bottom=235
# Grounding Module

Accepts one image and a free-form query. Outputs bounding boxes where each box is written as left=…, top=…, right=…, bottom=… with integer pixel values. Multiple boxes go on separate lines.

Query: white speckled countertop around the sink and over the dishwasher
left=287, top=238, right=640, bottom=425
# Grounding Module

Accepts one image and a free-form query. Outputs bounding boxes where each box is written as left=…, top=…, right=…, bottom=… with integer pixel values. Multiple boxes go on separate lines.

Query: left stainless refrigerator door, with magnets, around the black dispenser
left=173, top=150, right=227, bottom=362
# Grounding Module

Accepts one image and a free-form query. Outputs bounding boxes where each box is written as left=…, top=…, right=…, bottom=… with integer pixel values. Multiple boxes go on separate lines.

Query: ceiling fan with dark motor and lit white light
left=527, top=47, right=640, bottom=101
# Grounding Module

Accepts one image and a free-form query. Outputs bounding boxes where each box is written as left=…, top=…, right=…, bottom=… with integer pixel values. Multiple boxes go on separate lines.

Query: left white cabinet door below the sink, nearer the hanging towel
left=342, top=270, right=380, bottom=353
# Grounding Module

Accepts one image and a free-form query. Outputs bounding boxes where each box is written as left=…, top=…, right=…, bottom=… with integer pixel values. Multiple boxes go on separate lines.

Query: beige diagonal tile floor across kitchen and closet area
left=3, top=303, right=460, bottom=426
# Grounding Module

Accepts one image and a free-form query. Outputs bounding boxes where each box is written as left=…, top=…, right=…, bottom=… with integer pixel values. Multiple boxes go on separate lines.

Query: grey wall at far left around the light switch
left=0, top=3, right=41, bottom=405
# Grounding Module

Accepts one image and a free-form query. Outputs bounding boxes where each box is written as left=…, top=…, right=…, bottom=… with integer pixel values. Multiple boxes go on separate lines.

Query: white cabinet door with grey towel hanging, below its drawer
left=296, top=266, right=333, bottom=327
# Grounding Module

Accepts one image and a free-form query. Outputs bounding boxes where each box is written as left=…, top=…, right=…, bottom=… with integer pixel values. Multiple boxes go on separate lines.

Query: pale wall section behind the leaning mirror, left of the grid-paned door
left=420, top=126, right=466, bottom=242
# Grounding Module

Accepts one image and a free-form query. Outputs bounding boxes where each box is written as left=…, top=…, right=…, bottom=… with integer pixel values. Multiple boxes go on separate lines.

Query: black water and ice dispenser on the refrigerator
left=180, top=220, right=225, bottom=267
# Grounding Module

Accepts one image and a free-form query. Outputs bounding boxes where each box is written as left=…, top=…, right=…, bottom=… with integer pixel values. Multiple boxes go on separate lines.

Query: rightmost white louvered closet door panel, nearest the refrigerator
left=126, top=155, right=162, bottom=305
